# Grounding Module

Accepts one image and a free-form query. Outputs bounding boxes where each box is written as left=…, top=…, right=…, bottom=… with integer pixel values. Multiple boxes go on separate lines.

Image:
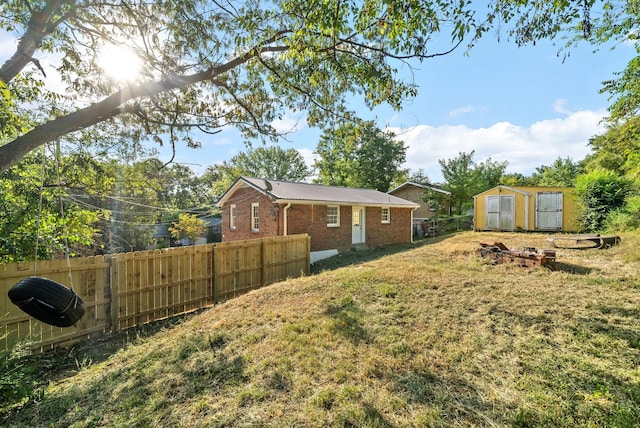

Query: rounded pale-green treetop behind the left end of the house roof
left=206, top=145, right=311, bottom=197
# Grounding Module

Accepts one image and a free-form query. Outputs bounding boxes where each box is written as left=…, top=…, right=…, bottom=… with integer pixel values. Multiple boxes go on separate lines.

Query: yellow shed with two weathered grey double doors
left=473, top=186, right=579, bottom=232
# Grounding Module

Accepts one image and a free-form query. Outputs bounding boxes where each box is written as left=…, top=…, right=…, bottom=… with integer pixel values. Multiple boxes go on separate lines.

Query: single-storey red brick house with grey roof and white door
left=218, top=177, right=418, bottom=261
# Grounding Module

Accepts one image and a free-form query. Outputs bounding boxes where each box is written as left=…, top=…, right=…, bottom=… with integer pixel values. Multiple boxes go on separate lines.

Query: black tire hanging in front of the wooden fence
left=8, top=276, right=84, bottom=327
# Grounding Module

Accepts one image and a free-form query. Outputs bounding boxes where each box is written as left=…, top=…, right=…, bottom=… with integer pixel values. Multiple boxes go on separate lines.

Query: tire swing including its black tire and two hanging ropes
left=7, top=147, right=85, bottom=327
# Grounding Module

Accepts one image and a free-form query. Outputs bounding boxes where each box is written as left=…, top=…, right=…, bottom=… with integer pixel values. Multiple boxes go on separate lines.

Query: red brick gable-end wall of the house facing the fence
left=222, top=188, right=282, bottom=242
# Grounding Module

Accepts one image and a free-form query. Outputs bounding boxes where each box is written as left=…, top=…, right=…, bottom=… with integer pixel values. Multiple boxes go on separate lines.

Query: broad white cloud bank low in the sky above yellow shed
left=389, top=110, right=606, bottom=182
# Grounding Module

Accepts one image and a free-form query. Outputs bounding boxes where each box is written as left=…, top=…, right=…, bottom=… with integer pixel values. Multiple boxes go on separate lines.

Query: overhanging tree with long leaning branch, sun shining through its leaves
left=0, top=0, right=496, bottom=173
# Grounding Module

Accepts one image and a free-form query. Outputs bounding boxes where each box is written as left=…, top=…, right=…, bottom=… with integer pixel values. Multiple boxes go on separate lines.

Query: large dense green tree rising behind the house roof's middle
left=315, top=121, right=408, bottom=192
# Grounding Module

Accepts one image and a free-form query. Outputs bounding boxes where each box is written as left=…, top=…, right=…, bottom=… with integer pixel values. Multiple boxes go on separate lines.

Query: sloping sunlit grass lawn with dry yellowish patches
left=0, top=232, right=640, bottom=427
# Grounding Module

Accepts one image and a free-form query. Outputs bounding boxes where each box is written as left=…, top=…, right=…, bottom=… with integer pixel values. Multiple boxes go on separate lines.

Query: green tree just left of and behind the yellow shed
left=438, top=151, right=508, bottom=214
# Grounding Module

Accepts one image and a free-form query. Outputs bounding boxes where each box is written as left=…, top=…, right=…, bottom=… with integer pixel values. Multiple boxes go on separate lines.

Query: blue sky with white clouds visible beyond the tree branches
left=0, top=23, right=635, bottom=182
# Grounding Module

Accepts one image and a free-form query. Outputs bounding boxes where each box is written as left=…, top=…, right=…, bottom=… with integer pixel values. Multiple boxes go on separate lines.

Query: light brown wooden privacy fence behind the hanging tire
left=0, top=235, right=310, bottom=350
